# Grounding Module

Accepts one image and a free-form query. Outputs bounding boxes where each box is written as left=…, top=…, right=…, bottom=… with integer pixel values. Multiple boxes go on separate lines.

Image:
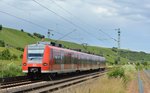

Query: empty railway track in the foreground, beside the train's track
left=0, top=72, right=105, bottom=93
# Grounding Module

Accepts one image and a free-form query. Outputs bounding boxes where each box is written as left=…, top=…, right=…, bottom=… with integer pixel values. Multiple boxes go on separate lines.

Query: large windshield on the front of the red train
left=28, top=49, right=44, bottom=63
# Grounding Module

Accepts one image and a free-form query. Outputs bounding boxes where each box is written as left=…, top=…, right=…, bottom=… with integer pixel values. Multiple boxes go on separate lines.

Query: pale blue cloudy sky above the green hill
left=0, top=0, right=150, bottom=53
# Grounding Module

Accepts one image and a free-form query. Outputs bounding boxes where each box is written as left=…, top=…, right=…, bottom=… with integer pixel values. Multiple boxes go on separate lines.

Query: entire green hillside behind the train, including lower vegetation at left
left=0, top=28, right=150, bottom=77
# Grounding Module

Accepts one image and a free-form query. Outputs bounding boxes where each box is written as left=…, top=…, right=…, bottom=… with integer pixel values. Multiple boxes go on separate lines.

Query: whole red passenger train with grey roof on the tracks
left=22, top=42, right=105, bottom=73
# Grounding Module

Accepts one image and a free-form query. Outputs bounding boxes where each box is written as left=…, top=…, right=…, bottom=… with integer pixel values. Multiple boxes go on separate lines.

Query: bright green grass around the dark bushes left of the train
left=0, top=47, right=23, bottom=77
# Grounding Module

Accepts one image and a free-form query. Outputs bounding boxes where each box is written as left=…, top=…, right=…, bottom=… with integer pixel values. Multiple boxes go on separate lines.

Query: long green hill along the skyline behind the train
left=0, top=27, right=150, bottom=63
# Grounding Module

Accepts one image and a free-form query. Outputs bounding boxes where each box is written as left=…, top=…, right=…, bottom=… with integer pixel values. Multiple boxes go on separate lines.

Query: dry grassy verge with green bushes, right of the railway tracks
left=60, top=65, right=136, bottom=93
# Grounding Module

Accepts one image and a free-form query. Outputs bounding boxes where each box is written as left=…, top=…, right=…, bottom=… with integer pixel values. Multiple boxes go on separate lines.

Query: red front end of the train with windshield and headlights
left=22, top=44, right=50, bottom=74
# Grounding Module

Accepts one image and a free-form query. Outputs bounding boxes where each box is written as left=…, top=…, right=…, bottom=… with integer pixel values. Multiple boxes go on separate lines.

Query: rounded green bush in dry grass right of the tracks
left=108, top=67, right=125, bottom=78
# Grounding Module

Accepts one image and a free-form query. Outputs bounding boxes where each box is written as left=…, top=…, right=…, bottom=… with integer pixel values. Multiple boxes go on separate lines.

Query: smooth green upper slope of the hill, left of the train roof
left=0, top=28, right=40, bottom=48
